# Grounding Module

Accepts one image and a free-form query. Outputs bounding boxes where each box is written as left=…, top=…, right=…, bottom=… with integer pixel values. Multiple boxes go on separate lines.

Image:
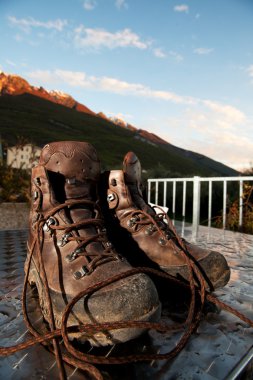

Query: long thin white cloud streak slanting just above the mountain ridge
left=27, top=69, right=246, bottom=120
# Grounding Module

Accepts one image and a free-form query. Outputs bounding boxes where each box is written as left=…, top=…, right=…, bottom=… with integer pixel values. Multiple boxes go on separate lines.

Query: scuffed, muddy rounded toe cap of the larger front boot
left=65, top=274, right=161, bottom=345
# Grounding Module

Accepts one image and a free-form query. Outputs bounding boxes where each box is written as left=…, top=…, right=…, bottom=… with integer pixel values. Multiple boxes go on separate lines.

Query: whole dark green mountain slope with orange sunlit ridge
left=0, top=73, right=238, bottom=177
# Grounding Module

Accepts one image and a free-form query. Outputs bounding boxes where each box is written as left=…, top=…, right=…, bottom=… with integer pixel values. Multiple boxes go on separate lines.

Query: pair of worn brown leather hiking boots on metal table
left=25, top=141, right=230, bottom=345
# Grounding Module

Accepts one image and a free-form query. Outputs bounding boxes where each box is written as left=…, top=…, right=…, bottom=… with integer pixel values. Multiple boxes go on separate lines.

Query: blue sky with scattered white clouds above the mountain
left=0, top=0, right=253, bottom=170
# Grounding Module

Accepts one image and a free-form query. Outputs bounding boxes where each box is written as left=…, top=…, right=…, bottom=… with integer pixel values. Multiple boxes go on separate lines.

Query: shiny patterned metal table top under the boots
left=0, top=226, right=253, bottom=380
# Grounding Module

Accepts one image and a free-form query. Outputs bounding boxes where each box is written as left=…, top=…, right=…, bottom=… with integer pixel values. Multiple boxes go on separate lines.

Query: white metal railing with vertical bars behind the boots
left=148, top=176, right=253, bottom=235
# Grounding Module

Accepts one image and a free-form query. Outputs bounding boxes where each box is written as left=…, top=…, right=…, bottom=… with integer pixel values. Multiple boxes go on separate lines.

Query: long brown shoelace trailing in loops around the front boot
left=0, top=201, right=253, bottom=380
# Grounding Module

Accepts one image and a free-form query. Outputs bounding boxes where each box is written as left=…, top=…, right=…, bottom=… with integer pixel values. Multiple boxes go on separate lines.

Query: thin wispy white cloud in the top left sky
left=8, top=16, right=68, bottom=33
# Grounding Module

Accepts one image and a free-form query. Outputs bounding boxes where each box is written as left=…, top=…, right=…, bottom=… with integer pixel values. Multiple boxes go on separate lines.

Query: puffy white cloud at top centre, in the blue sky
left=74, top=25, right=150, bottom=49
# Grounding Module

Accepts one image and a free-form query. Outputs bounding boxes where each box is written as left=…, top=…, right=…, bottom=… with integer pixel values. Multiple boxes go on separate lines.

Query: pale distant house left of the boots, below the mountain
left=7, top=144, right=41, bottom=169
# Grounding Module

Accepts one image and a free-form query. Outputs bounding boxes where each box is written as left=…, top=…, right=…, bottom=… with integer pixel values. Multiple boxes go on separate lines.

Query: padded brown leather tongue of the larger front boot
left=40, top=141, right=100, bottom=254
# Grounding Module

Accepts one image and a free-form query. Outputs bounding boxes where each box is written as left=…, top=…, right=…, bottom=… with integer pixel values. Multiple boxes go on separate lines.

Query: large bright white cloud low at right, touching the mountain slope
left=166, top=100, right=249, bottom=169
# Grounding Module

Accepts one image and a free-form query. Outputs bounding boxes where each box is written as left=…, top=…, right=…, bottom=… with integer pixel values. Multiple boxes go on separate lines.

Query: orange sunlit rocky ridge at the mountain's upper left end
left=0, top=72, right=95, bottom=115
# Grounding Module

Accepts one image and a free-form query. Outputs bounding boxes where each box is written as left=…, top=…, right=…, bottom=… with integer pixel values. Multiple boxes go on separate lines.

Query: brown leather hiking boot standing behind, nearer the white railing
left=101, top=152, right=230, bottom=290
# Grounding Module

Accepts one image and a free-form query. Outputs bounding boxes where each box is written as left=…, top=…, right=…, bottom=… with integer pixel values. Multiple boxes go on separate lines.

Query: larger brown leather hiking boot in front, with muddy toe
left=25, top=141, right=160, bottom=345
